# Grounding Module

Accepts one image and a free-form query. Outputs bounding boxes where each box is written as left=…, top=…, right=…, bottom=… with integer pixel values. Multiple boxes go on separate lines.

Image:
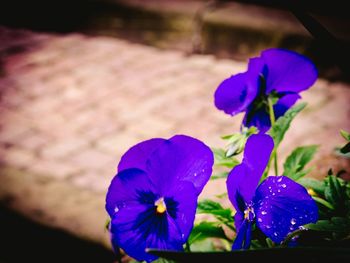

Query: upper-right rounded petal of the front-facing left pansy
left=146, top=135, right=214, bottom=195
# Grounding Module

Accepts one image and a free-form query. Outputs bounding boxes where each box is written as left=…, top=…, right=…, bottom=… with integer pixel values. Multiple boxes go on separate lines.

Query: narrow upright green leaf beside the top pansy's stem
left=269, top=102, right=306, bottom=148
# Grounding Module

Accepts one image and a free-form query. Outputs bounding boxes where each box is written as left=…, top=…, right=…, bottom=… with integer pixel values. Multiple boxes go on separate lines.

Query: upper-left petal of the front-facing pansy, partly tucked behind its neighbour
left=118, top=138, right=166, bottom=171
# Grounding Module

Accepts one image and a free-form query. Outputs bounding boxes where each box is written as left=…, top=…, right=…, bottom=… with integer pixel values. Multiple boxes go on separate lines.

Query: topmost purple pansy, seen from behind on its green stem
left=214, top=48, right=317, bottom=133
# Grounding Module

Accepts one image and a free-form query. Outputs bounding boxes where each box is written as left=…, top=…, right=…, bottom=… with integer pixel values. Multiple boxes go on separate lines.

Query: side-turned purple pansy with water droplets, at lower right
left=226, top=134, right=318, bottom=249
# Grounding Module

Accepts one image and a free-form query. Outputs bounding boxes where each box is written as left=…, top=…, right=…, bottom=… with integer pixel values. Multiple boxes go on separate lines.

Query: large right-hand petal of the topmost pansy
left=261, top=48, right=318, bottom=94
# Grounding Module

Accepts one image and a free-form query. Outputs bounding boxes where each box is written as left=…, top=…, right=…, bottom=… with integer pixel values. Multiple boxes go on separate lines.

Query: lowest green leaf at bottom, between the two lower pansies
left=188, top=221, right=227, bottom=244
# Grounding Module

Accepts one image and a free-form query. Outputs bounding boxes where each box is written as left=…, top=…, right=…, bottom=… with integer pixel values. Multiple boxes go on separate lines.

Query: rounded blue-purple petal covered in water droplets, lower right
left=254, top=176, right=318, bottom=243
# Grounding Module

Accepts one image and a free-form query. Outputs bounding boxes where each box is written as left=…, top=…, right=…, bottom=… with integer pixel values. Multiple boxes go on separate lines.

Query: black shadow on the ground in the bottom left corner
left=0, top=204, right=115, bottom=263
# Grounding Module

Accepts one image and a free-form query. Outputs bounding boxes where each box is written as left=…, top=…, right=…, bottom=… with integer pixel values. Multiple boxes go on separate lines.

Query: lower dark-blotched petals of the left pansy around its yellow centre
left=111, top=181, right=197, bottom=261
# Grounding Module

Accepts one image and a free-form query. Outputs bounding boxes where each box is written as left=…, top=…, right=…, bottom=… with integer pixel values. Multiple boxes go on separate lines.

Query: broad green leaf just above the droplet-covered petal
left=283, top=145, right=318, bottom=180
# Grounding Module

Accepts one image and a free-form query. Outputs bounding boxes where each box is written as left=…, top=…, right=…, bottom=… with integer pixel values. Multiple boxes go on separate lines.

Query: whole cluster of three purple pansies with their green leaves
left=105, top=49, right=350, bottom=262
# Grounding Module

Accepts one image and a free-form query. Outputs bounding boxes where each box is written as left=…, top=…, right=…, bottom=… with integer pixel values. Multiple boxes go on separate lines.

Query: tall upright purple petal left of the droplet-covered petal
left=226, top=134, right=274, bottom=209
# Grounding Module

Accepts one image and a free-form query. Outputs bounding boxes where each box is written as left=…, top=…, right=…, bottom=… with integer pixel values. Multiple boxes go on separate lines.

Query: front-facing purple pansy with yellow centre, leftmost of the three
left=106, top=135, right=214, bottom=262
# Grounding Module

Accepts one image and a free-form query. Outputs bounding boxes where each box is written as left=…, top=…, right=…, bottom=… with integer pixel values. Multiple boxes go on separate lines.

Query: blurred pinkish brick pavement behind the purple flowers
left=0, top=27, right=350, bottom=255
